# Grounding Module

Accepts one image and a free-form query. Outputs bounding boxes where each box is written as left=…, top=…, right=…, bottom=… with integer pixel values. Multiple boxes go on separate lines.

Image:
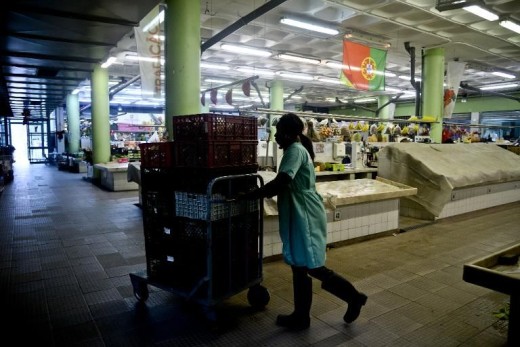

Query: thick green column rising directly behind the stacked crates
left=164, top=0, right=202, bottom=140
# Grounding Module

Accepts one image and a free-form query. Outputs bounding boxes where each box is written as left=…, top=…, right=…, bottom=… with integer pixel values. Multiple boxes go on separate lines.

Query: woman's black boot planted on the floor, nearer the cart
left=276, top=267, right=312, bottom=330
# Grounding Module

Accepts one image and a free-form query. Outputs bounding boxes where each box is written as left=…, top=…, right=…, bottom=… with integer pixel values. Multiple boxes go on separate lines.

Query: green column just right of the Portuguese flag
left=416, top=48, right=444, bottom=143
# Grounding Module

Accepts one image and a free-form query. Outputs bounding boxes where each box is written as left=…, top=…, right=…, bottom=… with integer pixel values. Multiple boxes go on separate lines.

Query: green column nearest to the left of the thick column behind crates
left=90, top=65, right=110, bottom=167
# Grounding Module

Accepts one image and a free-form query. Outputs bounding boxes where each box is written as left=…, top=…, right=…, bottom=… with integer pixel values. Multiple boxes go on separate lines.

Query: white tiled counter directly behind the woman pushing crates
left=259, top=172, right=417, bottom=257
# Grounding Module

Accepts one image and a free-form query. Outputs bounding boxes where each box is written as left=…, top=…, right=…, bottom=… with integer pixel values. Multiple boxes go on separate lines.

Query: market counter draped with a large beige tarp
left=378, top=143, right=520, bottom=217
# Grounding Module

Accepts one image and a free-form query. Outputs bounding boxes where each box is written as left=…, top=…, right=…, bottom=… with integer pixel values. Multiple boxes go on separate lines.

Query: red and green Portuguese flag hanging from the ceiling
left=340, top=40, right=386, bottom=90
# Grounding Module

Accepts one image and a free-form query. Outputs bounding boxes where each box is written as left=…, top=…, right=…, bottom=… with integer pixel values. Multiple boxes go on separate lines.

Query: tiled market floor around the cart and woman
left=0, top=164, right=520, bottom=347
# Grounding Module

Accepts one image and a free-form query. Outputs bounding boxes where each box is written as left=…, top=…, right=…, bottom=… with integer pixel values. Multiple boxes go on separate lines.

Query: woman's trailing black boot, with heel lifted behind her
left=321, top=271, right=367, bottom=323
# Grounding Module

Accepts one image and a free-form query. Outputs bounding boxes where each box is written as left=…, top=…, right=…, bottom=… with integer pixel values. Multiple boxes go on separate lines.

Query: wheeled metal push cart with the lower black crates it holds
left=130, top=174, right=270, bottom=321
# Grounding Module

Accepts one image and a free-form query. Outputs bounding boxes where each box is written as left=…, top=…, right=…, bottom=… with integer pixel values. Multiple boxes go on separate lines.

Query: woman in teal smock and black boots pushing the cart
left=237, top=113, right=367, bottom=330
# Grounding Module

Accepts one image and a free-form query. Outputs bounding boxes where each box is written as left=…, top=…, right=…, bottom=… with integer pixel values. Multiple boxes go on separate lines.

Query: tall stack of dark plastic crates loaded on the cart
left=140, top=114, right=260, bottom=297
